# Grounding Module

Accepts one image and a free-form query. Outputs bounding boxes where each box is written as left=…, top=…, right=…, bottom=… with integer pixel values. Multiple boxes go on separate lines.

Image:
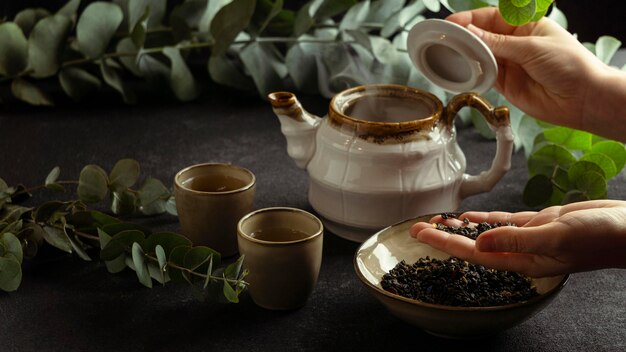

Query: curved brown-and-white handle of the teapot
left=443, top=93, right=513, bottom=199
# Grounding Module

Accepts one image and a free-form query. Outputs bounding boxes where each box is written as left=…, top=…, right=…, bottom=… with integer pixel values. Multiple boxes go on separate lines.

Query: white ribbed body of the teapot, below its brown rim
left=307, top=119, right=466, bottom=241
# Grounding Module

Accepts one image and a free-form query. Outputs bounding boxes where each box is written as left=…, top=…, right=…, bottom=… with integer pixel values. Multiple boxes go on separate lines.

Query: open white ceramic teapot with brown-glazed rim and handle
left=269, top=18, right=513, bottom=242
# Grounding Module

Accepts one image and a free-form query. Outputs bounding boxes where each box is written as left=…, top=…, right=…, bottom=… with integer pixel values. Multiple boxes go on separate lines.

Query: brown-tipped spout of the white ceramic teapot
left=268, top=92, right=322, bottom=169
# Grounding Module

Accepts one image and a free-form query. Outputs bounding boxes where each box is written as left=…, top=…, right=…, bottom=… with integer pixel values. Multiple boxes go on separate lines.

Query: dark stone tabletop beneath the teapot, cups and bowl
left=0, top=88, right=626, bottom=351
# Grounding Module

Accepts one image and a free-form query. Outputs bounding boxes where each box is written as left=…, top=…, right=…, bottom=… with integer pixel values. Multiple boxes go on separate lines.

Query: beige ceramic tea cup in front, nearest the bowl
left=237, top=208, right=324, bottom=310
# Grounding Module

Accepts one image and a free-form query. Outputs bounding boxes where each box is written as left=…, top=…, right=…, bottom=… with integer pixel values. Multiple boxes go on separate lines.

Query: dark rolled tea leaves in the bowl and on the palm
left=381, top=217, right=538, bottom=307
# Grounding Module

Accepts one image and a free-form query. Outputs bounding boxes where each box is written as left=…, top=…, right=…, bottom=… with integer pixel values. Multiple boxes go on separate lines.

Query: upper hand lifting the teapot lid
left=447, top=7, right=626, bottom=140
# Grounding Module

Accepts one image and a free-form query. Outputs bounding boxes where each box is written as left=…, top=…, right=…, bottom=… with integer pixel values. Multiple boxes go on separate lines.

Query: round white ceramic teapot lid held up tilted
left=407, top=19, right=498, bottom=93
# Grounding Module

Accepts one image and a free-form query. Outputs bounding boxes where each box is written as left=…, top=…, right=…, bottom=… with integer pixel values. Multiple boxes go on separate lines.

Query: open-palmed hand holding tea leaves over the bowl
left=410, top=200, right=626, bottom=277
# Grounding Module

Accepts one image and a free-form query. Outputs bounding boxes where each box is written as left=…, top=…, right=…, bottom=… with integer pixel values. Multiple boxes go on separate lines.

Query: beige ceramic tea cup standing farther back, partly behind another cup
left=174, top=163, right=256, bottom=256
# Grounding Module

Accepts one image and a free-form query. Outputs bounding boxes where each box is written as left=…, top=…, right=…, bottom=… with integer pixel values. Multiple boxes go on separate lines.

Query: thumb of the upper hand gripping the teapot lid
left=467, top=23, right=531, bottom=65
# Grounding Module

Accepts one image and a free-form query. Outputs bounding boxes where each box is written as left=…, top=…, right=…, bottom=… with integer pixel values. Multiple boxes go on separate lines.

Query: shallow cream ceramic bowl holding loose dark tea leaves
left=354, top=215, right=569, bottom=339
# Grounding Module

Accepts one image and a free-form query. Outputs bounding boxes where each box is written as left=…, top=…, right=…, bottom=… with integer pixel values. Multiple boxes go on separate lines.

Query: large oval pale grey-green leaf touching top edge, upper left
left=76, top=1, right=124, bottom=58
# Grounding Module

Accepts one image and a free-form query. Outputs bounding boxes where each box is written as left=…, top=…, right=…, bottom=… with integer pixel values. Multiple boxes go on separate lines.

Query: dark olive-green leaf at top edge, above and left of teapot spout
left=211, top=0, right=256, bottom=56
